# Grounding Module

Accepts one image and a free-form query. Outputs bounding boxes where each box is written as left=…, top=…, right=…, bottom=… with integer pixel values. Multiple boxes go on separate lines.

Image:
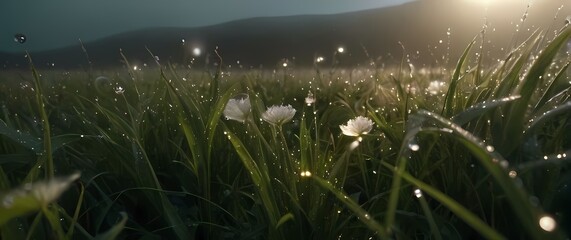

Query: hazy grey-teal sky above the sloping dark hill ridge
left=0, top=0, right=414, bottom=51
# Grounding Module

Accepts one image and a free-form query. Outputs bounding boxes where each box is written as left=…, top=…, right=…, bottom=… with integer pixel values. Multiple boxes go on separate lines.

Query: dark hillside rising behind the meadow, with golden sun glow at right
left=0, top=0, right=569, bottom=68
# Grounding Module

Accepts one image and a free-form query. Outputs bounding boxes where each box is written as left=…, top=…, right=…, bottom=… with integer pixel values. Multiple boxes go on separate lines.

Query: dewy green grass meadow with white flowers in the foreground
left=0, top=25, right=571, bottom=239
